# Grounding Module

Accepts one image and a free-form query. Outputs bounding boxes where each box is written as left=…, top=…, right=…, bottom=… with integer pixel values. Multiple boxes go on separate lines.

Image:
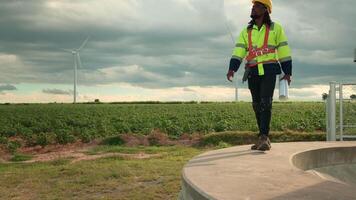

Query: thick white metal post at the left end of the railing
left=328, top=82, right=336, bottom=141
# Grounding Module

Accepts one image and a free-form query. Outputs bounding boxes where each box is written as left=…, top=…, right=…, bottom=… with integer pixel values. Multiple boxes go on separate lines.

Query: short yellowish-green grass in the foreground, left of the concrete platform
left=0, top=146, right=208, bottom=200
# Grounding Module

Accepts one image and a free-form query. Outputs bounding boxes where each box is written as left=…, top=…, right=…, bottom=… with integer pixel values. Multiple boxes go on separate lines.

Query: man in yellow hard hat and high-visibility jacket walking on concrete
left=226, top=0, right=292, bottom=151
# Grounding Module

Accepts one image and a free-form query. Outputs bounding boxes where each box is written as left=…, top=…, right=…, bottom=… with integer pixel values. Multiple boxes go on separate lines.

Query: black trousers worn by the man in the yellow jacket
left=248, top=74, right=276, bottom=136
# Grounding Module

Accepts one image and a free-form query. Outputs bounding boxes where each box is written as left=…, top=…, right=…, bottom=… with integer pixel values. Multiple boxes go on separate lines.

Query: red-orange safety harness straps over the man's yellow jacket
left=246, top=25, right=278, bottom=67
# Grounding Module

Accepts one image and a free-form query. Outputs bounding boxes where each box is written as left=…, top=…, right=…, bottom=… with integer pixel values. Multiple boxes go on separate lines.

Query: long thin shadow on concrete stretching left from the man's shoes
left=186, top=150, right=265, bottom=167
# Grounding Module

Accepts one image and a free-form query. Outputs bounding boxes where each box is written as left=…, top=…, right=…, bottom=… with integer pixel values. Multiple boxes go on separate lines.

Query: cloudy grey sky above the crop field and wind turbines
left=0, top=0, right=356, bottom=103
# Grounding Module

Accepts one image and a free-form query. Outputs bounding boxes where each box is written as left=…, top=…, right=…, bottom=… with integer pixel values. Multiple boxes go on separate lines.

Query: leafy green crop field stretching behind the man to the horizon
left=0, top=102, right=332, bottom=149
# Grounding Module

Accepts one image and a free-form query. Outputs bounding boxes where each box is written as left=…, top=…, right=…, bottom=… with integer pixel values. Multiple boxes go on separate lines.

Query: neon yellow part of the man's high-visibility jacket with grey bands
left=232, top=22, right=291, bottom=75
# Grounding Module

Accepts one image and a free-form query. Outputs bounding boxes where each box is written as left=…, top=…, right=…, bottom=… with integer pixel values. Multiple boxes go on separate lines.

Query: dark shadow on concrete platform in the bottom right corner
left=269, top=181, right=356, bottom=200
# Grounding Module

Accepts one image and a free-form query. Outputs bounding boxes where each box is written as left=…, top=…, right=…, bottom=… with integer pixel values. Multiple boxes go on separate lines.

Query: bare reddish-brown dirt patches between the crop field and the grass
left=0, top=133, right=202, bottom=163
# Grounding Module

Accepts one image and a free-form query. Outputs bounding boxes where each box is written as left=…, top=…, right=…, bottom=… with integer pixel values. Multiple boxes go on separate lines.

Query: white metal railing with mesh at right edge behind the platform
left=326, top=82, right=356, bottom=141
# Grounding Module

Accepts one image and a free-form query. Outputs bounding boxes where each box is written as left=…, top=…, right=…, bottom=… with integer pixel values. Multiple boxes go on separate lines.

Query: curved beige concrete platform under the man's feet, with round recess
left=179, top=142, right=356, bottom=200
